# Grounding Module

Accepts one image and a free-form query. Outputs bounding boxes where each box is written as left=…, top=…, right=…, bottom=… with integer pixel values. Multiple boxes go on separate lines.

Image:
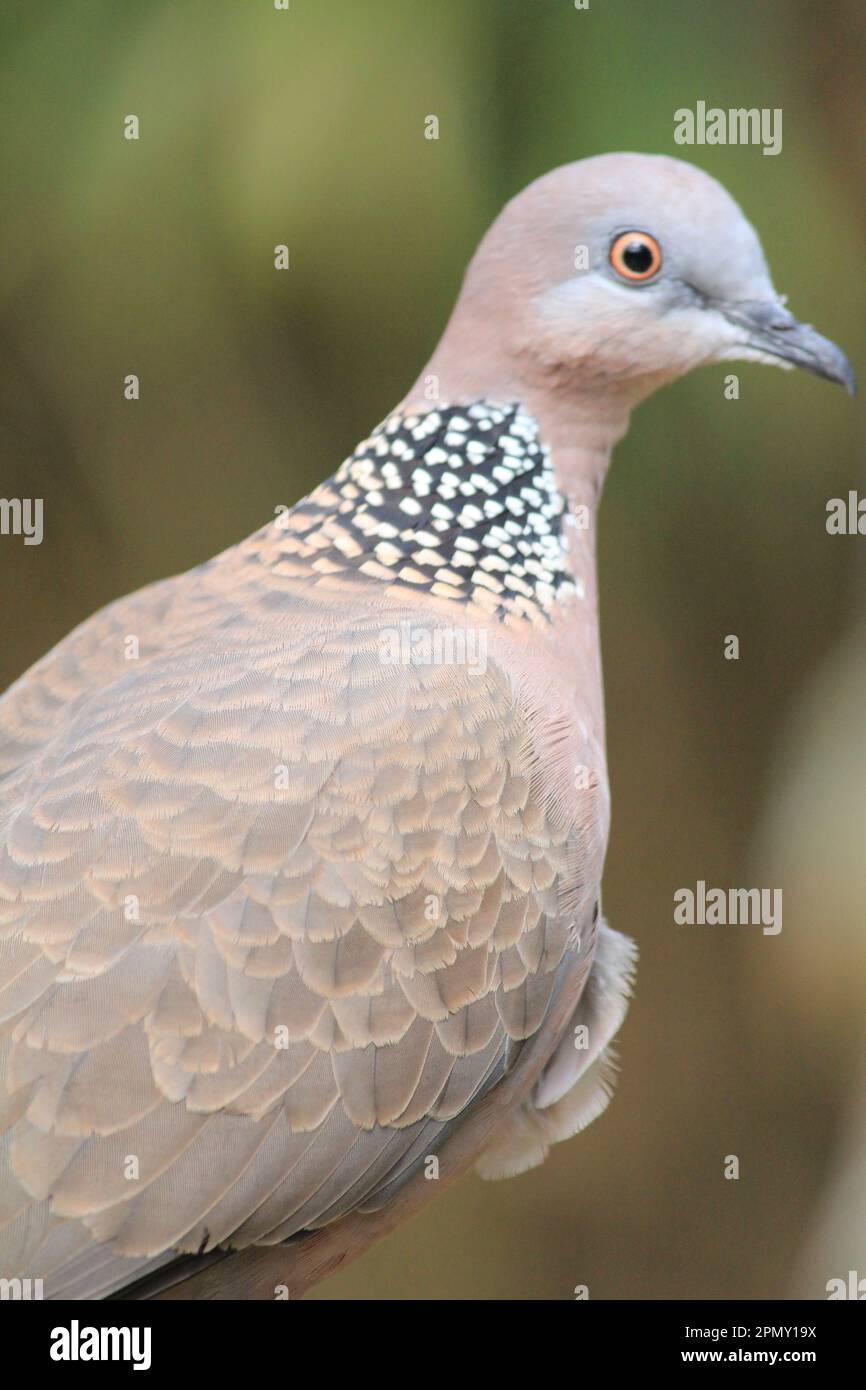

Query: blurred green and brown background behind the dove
left=0, top=0, right=866, bottom=1298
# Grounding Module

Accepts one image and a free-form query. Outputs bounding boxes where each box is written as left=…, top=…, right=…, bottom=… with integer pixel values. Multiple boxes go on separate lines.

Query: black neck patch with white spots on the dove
left=273, top=400, right=575, bottom=620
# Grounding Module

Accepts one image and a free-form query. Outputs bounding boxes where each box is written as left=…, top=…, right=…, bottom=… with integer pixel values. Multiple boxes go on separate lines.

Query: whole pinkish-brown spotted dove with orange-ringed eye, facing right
left=0, top=153, right=853, bottom=1300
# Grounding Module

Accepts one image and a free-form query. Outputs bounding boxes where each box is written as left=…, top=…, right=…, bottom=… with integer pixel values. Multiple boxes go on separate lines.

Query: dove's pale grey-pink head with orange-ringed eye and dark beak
left=455, top=154, right=855, bottom=403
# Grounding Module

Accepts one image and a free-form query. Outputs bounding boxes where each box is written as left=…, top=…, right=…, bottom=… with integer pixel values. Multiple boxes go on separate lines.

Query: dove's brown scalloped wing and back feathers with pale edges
left=0, top=537, right=617, bottom=1297
